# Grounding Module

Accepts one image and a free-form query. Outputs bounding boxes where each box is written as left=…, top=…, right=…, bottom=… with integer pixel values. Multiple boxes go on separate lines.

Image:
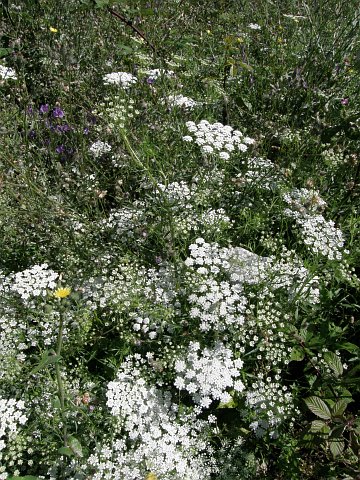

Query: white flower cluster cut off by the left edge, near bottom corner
left=0, top=398, right=27, bottom=480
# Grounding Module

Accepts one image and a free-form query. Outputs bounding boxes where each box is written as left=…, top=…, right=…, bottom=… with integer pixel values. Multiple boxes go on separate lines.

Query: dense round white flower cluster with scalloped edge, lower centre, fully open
left=174, top=342, right=244, bottom=408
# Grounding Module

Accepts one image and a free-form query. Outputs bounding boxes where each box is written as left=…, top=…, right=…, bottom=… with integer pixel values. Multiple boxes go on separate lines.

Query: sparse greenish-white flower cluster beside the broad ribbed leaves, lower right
left=246, top=375, right=297, bottom=438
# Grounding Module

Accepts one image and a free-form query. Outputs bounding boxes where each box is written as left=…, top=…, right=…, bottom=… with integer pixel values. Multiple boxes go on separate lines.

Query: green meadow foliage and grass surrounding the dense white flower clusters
left=0, top=0, right=360, bottom=480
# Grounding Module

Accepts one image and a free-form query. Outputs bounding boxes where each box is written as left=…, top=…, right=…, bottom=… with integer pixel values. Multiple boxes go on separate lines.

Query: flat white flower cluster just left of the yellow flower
left=8, top=263, right=59, bottom=303
